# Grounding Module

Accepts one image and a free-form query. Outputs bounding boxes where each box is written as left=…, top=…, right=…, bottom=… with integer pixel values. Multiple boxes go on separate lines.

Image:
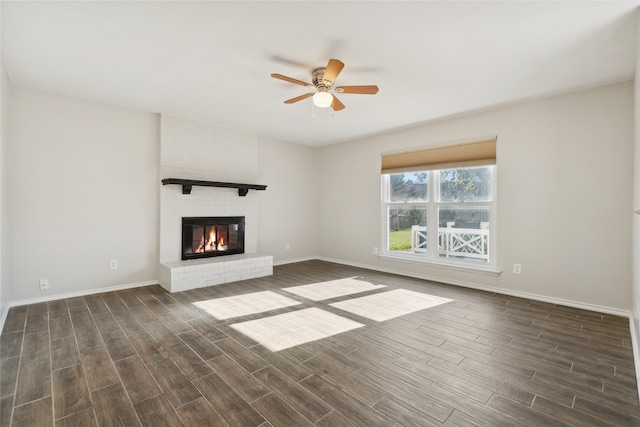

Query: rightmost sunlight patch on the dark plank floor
left=329, top=289, right=453, bottom=322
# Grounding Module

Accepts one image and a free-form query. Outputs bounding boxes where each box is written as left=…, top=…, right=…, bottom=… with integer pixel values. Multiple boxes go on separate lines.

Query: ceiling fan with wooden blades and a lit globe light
left=271, top=59, right=378, bottom=111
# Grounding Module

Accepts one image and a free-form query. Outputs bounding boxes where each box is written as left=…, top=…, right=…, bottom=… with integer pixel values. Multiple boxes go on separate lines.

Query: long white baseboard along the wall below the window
left=316, top=257, right=640, bottom=320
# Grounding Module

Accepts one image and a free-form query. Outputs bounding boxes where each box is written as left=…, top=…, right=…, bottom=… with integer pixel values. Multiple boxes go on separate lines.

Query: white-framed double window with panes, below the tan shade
left=382, top=141, right=496, bottom=266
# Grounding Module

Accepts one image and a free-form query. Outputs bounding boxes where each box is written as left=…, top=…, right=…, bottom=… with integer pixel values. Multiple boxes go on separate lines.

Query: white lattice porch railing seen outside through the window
left=411, top=225, right=489, bottom=261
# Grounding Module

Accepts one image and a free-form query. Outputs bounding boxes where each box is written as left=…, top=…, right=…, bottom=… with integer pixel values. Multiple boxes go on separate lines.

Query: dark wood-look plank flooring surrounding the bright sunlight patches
left=0, top=261, right=640, bottom=427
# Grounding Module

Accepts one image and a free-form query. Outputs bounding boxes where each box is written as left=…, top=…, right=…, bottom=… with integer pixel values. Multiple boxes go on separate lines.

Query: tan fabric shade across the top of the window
left=382, top=138, right=496, bottom=174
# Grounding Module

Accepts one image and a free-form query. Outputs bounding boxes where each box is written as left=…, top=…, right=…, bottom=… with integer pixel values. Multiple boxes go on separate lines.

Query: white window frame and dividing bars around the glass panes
left=379, top=164, right=498, bottom=274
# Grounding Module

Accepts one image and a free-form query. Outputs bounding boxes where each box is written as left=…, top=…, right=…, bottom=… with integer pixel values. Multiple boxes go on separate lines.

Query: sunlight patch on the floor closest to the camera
left=231, top=307, right=364, bottom=351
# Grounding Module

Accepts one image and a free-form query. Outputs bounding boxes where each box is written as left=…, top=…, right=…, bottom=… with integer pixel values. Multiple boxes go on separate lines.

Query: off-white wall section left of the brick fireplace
left=8, top=86, right=160, bottom=303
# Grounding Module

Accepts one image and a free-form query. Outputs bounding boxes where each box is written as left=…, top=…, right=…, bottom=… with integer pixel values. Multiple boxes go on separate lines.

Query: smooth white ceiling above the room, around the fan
left=1, top=0, right=639, bottom=146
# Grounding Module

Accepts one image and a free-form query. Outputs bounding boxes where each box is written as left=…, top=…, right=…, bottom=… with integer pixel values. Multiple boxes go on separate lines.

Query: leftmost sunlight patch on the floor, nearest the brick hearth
left=193, top=291, right=302, bottom=320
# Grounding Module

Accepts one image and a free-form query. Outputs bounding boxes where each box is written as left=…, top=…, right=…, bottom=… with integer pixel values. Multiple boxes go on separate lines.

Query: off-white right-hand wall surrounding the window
left=317, top=82, right=633, bottom=310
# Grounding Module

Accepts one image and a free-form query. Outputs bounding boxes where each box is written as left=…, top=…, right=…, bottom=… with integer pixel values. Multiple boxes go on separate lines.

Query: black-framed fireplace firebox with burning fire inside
left=182, top=216, right=244, bottom=260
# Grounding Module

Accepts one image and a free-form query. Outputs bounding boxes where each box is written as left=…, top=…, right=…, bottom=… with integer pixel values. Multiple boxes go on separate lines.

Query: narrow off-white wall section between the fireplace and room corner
left=257, top=138, right=318, bottom=264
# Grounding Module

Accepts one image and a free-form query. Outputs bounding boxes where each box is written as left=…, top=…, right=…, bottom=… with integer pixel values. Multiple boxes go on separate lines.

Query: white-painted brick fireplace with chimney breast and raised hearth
left=159, top=115, right=273, bottom=292
